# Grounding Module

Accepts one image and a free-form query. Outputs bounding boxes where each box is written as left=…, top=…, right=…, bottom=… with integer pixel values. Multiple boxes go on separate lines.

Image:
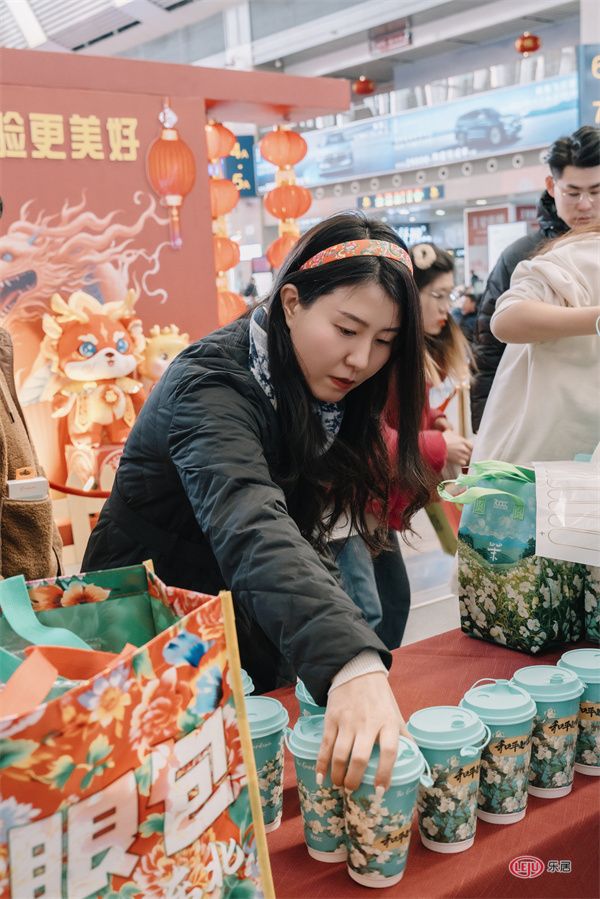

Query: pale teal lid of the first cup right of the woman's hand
left=407, top=705, right=486, bottom=749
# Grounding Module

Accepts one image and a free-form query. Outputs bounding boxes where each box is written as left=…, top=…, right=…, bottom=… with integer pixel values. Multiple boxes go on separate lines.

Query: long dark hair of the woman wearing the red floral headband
left=267, top=212, right=431, bottom=551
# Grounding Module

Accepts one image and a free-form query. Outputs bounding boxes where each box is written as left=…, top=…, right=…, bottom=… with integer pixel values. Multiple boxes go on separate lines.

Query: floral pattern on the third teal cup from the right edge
left=477, top=731, right=531, bottom=815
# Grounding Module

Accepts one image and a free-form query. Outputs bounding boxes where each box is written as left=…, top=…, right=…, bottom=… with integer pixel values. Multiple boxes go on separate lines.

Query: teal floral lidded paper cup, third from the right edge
left=459, top=678, right=536, bottom=824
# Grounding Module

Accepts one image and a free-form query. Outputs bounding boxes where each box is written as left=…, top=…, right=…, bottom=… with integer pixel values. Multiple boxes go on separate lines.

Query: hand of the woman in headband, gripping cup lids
left=317, top=671, right=410, bottom=790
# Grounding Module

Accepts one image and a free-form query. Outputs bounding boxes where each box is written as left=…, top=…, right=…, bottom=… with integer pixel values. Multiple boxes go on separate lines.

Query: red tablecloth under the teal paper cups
left=267, top=630, right=600, bottom=899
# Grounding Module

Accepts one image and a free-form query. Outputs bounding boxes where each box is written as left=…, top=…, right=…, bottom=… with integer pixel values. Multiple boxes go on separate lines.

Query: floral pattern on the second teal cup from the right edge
left=529, top=708, right=577, bottom=790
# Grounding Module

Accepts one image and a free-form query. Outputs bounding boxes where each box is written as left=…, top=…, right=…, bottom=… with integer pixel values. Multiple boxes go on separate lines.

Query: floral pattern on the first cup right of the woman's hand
left=417, top=755, right=480, bottom=843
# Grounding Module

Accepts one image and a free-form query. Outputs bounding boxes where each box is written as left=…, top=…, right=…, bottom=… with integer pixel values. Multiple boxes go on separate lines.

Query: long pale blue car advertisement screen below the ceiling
left=256, top=73, right=578, bottom=192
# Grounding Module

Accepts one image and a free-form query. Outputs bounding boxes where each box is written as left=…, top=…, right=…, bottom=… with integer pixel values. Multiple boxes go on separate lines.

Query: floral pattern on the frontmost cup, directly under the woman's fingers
left=344, top=790, right=412, bottom=876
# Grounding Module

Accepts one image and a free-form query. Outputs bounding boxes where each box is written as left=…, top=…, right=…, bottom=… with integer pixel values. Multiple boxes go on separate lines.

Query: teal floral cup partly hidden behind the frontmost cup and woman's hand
left=286, top=715, right=347, bottom=862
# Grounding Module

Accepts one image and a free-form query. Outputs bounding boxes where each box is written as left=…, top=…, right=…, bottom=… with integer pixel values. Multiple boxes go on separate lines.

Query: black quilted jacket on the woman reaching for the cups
left=83, top=320, right=391, bottom=705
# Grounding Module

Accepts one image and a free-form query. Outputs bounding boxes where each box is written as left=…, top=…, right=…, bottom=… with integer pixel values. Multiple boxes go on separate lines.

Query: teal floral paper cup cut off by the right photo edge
left=558, top=649, right=600, bottom=777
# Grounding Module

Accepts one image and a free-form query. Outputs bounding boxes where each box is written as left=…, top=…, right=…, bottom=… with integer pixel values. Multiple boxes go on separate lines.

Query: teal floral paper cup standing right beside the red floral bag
left=246, top=696, right=289, bottom=833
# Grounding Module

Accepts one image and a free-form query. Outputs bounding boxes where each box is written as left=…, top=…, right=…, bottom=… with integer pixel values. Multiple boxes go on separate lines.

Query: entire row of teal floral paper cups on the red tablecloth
left=241, top=649, right=600, bottom=886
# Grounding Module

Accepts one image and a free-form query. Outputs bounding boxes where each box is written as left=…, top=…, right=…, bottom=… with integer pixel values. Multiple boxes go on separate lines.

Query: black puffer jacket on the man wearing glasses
left=471, top=191, right=569, bottom=432
